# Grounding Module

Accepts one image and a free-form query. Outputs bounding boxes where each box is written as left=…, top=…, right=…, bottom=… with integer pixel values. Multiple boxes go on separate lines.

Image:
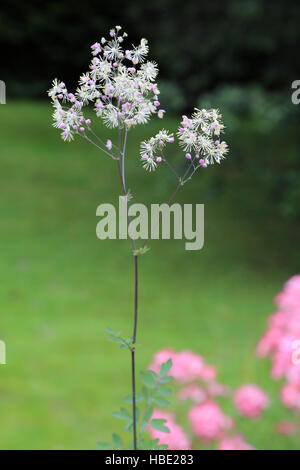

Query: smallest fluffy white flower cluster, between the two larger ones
left=140, top=129, right=174, bottom=171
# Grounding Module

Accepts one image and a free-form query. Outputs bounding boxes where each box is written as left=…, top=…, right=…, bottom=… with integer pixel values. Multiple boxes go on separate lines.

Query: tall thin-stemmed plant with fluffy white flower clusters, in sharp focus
left=48, top=26, right=228, bottom=449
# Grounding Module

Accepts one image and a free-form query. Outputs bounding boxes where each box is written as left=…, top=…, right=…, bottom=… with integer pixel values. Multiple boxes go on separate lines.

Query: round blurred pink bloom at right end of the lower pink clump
left=233, top=384, right=269, bottom=418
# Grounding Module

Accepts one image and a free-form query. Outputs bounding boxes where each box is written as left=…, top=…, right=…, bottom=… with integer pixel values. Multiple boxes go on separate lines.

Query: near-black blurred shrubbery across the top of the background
left=0, top=0, right=300, bottom=105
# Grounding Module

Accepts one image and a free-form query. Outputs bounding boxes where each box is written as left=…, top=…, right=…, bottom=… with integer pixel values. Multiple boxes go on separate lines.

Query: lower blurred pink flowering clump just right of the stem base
left=149, top=349, right=269, bottom=450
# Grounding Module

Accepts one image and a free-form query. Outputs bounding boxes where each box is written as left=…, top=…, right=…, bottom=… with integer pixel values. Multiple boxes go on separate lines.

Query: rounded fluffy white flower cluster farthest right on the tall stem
left=178, top=108, right=228, bottom=166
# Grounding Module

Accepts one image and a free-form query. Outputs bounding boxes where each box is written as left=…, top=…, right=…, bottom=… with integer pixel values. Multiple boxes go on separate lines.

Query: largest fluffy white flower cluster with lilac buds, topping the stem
left=48, top=26, right=164, bottom=140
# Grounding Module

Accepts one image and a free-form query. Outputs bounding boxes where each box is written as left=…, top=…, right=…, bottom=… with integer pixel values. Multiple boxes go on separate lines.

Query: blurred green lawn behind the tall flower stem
left=0, top=103, right=299, bottom=449
